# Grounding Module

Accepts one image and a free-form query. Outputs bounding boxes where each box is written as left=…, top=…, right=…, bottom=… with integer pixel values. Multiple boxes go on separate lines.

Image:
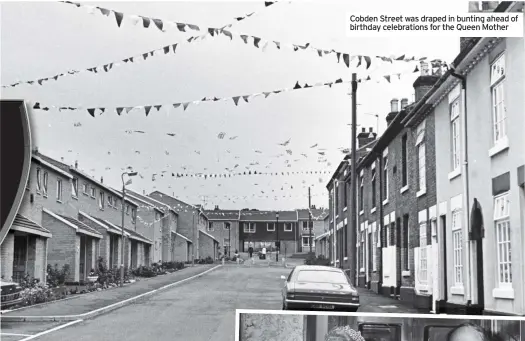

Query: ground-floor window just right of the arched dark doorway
left=494, top=193, right=512, bottom=287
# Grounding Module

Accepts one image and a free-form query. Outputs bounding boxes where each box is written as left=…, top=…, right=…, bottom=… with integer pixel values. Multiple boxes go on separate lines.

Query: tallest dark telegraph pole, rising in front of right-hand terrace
left=346, top=73, right=357, bottom=285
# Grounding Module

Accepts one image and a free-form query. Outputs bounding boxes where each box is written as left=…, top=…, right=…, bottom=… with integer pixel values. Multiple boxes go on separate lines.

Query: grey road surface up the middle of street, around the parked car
left=1, top=265, right=420, bottom=341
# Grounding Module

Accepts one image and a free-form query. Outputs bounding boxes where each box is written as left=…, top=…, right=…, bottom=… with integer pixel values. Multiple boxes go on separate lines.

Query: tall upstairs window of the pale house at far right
left=490, top=54, right=507, bottom=144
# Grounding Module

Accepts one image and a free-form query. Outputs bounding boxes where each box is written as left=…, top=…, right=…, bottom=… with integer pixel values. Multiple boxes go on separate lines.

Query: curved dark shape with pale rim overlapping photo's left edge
left=0, top=100, right=31, bottom=243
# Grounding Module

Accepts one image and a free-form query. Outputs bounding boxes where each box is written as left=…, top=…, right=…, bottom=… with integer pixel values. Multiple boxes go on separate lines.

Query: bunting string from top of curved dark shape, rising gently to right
left=29, top=66, right=426, bottom=117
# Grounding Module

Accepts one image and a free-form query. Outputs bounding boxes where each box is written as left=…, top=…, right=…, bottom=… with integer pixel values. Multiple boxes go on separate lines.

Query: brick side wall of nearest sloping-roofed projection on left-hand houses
left=42, top=212, right=80, bottom=281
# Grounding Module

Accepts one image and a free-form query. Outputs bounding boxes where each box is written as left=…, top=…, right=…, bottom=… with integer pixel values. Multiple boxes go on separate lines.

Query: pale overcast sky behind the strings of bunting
left=0, top=0, right=458, bottom=209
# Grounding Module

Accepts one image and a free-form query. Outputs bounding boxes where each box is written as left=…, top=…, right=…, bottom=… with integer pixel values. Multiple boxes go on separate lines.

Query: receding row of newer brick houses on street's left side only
left=0, top=150, right=223, bottom=283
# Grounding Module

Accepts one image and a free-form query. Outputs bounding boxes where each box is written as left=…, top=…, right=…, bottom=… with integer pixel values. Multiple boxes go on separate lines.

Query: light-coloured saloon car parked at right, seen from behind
left=281, top=265, right=359, bottom=312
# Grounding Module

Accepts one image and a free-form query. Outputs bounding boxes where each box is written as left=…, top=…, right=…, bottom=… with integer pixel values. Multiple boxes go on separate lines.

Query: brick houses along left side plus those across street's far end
left=0, top=146, right=327, bottom=283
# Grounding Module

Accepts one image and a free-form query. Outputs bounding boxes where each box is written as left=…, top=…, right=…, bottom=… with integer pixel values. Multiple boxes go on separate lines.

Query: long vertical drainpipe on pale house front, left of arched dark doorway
left=451, top=69, right=473, bottom=306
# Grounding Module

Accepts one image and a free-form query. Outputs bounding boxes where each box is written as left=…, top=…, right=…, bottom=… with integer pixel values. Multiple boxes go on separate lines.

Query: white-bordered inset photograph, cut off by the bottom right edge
left=236, top=310, right=525, bottom=341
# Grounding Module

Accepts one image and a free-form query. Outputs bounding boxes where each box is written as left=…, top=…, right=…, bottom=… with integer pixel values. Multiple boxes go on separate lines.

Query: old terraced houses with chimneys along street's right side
left=316, top=2, right=525, bottom=315
